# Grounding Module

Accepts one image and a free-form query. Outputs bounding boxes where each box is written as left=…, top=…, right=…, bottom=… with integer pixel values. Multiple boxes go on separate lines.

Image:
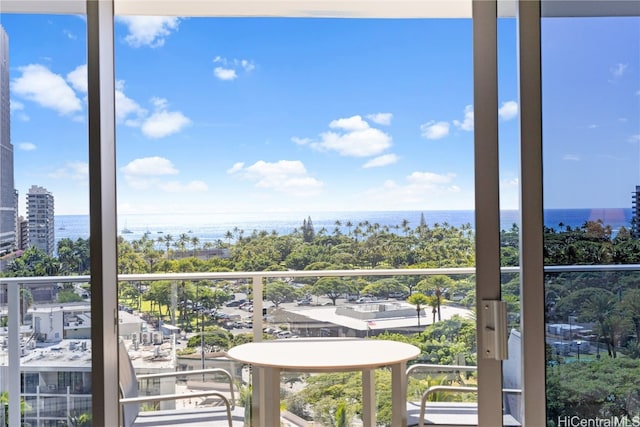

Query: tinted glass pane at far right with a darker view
left=542, top=17, right=640, bottom=426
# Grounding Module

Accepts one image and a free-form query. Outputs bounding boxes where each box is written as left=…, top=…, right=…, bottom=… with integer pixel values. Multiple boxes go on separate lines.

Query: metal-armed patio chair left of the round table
left=119, top=341, right=244, bottom=427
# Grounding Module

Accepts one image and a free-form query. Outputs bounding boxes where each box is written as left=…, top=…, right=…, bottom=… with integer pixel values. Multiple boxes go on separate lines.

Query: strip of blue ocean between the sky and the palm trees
left=55, top=208, right=632, bottom=244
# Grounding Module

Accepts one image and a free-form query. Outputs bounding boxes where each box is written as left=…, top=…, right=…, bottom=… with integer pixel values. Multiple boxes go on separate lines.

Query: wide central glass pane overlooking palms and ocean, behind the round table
left=115, top=17, right=478, bottom=425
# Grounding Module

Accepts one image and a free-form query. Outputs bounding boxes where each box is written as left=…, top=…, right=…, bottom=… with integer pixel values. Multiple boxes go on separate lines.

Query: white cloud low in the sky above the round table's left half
left=228, top=160, right=323, bottom=197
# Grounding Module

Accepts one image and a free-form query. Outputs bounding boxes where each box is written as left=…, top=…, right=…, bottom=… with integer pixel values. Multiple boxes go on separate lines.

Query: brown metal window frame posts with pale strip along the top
left=2, top=0, right=639, bottom=426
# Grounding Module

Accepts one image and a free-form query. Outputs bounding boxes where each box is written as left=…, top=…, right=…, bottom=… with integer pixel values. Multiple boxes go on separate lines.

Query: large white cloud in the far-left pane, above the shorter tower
left=11, top=64, right=82, bottom=115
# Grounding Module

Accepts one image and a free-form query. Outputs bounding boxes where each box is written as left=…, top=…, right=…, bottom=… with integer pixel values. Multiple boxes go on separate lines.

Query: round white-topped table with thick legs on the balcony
left=227, top=338, right=420, bottom=427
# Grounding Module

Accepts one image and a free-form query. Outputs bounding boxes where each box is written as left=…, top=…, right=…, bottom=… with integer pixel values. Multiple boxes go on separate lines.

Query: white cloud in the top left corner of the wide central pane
left=117, top=16, right=180, bottom=47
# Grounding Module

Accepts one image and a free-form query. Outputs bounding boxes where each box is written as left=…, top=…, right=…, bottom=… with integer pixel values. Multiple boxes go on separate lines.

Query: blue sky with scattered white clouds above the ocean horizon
left=1, top=15, right=640, bottom=214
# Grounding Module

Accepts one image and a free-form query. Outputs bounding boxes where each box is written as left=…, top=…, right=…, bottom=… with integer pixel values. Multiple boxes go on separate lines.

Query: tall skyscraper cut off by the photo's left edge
left=0, top=25, right=18, bottom=255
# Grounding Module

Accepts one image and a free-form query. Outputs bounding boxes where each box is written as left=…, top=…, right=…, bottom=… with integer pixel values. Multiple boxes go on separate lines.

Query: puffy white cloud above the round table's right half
left=298, top=115, right=392, bottom=157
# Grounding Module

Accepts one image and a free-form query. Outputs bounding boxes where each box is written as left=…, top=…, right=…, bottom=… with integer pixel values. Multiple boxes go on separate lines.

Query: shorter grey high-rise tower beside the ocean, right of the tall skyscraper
left=27, top=185, right=55, bottom=256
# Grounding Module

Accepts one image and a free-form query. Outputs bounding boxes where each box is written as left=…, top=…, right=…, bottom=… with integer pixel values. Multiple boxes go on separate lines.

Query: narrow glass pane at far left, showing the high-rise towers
left=0, top=14, right=91, bottom=426
